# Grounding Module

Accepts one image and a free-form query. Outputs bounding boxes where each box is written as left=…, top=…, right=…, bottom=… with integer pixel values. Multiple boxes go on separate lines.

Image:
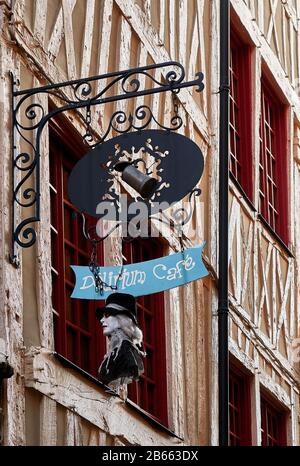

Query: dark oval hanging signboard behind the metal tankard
left=68, top=130, right=204, bottom=221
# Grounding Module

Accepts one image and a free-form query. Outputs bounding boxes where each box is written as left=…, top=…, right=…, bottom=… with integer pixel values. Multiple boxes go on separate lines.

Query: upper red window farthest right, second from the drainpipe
left=259, top=79, right=288, bottom=244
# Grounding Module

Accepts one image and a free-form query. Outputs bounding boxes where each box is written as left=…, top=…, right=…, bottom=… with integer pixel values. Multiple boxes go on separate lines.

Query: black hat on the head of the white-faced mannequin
left=96, top=293, right=138, bottom=325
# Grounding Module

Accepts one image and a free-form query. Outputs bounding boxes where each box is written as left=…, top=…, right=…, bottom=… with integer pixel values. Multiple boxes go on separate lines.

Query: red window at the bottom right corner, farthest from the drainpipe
left=261, top=395, right=286, bottom=447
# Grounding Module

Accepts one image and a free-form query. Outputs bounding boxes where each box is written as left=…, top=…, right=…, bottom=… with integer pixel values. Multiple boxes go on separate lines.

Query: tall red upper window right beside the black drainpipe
left=229, top=30, right=252, bottom=199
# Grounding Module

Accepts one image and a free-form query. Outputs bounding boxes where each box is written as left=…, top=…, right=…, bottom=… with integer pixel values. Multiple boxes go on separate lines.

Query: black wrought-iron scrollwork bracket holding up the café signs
left=10, top=62, right=204, bottom=267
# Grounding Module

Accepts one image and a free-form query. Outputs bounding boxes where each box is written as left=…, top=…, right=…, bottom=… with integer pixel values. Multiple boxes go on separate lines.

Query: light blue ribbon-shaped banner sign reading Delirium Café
left=71, top=243, right=208, bottom=299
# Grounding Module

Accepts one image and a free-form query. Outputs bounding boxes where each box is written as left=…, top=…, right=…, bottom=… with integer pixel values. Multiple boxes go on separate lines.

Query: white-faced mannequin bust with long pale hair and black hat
left=96, top=293, right=146, bottom=389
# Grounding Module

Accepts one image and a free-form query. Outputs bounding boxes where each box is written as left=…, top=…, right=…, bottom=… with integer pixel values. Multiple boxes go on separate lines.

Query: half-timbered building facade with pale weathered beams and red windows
left=0, top=0, right=300, bottom=446
